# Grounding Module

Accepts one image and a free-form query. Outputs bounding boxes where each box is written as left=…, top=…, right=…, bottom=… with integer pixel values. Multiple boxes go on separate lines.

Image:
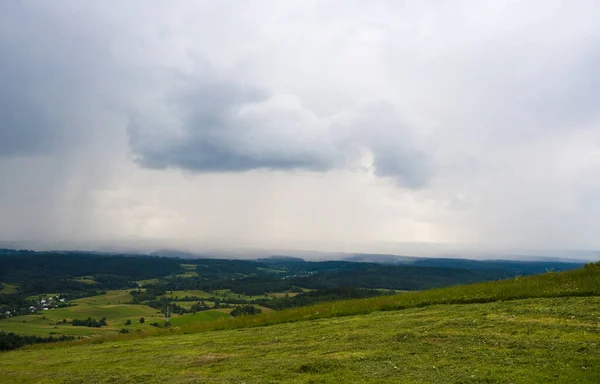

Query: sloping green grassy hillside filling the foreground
left=0, top=264, right=600, bottom=383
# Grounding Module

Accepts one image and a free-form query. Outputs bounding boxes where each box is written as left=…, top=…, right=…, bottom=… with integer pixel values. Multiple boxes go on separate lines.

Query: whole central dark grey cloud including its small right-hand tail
left=128, top=74, right=430, bottom=188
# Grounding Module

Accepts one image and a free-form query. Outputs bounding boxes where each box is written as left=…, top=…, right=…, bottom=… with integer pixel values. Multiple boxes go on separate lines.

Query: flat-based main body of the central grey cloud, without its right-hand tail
left=128, top=76, right=332, bottom=172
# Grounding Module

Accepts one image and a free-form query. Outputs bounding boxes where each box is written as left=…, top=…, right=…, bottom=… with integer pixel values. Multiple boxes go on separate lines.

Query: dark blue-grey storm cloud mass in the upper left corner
left=0, top=2, right=116, bottom=157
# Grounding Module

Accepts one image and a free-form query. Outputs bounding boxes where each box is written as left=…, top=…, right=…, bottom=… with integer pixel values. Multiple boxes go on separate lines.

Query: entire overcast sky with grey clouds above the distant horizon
left=0, top=0, right=600, bottom=252
